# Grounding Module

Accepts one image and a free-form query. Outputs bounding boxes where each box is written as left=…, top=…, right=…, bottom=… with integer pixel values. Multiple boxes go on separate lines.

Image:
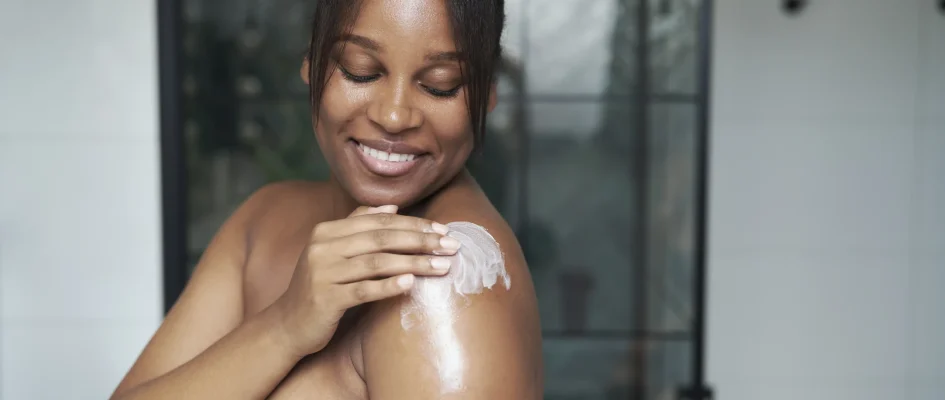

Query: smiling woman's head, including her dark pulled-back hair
left=301, top=0, right=505, bottom=207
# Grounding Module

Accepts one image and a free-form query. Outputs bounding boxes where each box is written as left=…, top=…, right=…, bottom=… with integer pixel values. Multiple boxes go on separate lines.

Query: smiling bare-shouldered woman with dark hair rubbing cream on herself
left=113, top=0, right=542, bottom=400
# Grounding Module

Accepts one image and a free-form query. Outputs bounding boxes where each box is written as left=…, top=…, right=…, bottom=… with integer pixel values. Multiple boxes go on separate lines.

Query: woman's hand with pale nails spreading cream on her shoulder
left=273, top=206, right=459, bottom=357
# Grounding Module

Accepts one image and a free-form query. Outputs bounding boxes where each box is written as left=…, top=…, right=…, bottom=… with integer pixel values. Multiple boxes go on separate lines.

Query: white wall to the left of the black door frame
left=0, top=0, right=161, bottom=400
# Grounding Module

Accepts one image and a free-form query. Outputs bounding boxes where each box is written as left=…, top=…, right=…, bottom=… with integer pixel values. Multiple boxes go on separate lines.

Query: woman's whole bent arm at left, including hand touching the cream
left=113, top=183, right=455, bottom=399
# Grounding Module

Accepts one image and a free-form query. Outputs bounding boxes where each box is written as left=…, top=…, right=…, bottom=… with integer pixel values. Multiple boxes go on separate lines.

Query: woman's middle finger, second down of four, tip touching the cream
left=328, top=229, right=460, bottom=258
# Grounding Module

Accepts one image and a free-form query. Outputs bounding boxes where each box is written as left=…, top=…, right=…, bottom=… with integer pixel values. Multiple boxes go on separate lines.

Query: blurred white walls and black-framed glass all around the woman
left=0, top=0, right=945, bottom=400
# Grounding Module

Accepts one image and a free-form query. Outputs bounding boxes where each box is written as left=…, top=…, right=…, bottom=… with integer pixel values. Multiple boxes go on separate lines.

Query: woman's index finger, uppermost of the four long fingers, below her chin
left=312, top=213, right=450, bottom=241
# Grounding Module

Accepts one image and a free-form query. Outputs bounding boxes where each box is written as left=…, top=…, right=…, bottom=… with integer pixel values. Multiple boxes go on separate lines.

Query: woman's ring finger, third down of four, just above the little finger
left=333, top=253, right=450, bottom=283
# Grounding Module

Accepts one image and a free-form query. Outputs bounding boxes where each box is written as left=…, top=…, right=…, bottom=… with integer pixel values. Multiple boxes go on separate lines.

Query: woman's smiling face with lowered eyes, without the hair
left=302, top=0, right=494, bottom=207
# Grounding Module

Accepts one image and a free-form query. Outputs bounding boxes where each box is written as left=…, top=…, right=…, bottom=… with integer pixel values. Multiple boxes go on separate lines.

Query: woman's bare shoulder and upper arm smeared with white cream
left=362, top=177, right=542, bottom=400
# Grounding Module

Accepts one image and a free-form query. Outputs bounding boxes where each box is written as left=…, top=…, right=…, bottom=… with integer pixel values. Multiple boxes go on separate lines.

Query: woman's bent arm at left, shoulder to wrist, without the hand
left=112, top=184, right=298, bottom=399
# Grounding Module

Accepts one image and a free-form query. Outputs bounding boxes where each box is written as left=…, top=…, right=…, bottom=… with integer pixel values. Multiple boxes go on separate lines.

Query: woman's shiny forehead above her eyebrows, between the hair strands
left=352, top=0, right=455, bottom=51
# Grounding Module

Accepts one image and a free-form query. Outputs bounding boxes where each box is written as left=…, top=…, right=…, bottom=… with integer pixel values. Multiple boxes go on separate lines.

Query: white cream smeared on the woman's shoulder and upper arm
left=400, top=222, right=512, bottom=393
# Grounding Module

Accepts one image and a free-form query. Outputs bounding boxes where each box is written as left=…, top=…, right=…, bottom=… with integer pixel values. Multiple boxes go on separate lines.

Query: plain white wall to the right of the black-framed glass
left=707, top=0, right=945, bottom=400
